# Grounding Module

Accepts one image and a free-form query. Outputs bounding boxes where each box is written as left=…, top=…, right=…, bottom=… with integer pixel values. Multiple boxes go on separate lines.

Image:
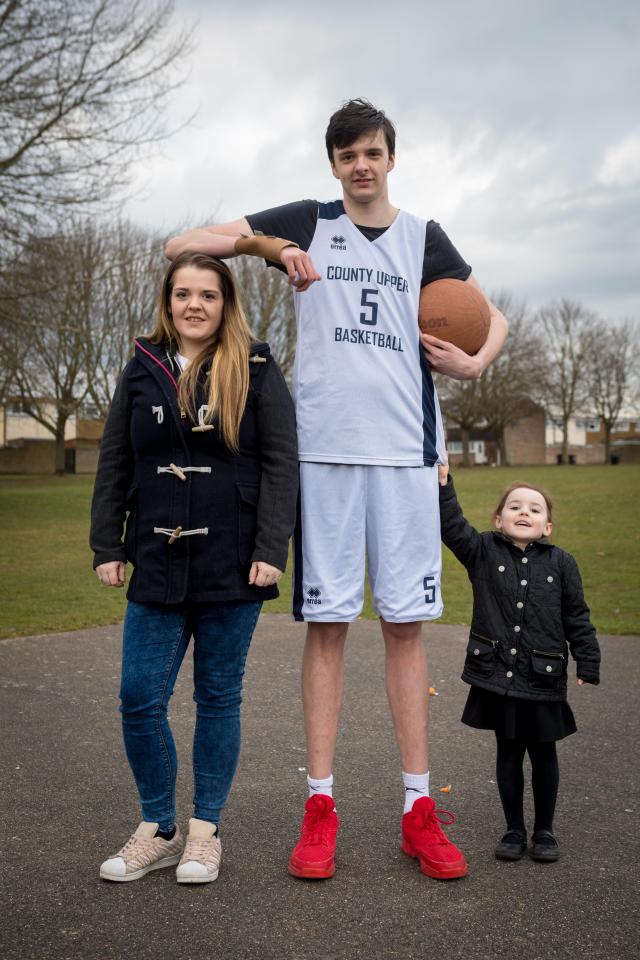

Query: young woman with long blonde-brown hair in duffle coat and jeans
left=91, top=252, right=298, bottom=883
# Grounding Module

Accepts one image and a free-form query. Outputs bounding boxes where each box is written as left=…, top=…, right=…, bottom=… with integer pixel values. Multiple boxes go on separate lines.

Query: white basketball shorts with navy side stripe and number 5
left=293, top=463, right=442, bottom=623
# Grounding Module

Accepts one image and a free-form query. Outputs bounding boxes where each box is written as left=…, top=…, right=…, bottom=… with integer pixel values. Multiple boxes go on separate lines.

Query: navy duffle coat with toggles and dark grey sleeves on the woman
left=90, top=338, right=298, bottom=604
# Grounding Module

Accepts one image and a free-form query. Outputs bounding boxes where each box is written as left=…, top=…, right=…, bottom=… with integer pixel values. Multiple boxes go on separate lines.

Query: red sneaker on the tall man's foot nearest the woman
left=289, top=793, right=338, bottom=880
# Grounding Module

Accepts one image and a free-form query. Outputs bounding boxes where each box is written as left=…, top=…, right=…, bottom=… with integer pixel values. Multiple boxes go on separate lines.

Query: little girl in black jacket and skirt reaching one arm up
left=439, top=466, right=600, bottom=862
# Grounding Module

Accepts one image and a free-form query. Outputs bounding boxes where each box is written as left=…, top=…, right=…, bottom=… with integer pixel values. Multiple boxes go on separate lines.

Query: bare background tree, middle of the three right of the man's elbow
left=535, top=299, right=596, bottom=463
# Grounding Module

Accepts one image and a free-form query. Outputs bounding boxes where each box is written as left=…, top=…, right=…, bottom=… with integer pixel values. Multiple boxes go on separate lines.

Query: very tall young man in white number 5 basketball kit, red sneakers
left=166, top=100, right=507, bottom=879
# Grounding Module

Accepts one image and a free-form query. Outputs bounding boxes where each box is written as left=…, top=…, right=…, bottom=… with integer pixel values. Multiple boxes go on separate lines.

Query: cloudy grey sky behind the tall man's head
left=127, top=0, right=640, bottom=320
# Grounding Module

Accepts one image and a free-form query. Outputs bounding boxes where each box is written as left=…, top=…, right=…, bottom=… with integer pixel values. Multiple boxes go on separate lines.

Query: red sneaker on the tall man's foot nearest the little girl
left=402, top=797, right=469, bottom=880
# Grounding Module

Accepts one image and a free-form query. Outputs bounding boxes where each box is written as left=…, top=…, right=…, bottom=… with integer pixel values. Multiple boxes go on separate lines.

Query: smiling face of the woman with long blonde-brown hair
left=171, top=266, right=224, bottom=360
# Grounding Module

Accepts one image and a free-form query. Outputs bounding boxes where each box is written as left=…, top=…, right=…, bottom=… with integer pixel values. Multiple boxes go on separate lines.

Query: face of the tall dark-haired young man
left=331, top=130, right=394, bottom=204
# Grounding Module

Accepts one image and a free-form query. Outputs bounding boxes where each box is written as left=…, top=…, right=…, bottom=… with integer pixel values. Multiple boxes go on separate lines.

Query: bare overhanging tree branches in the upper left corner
left=0, top=0, right=186, bottom=241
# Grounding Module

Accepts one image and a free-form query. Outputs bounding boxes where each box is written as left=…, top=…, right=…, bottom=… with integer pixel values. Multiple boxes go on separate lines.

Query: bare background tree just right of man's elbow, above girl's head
left=479, top=292, right=547, bottom=463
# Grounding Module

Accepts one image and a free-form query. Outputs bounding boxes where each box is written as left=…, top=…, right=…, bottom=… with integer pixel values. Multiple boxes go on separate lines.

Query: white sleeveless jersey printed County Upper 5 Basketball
left=293, top=200, right=444, bottom=467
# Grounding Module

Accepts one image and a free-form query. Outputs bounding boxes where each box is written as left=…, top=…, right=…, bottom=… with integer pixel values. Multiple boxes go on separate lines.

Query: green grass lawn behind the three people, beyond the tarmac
left=0, top=466, right=640, bottom=637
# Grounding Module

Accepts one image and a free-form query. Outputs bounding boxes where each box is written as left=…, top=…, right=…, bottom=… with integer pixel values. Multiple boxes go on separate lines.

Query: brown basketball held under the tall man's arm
left=418, top=279, right=491, bottom=354
